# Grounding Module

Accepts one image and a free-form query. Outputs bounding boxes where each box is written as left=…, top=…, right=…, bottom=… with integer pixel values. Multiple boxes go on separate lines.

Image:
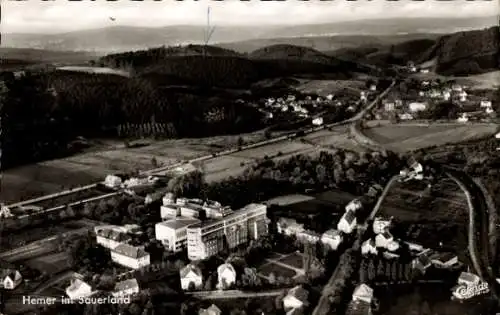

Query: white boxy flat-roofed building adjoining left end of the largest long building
left=155, top=218, right=201, bottom=252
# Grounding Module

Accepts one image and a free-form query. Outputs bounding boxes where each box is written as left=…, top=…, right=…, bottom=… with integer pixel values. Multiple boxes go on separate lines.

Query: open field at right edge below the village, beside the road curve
left=363, top=124, right=498, bottom=152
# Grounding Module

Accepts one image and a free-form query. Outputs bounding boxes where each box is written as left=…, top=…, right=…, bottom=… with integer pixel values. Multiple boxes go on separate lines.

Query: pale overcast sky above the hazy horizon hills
left=0, top=0, right=499, bottom=33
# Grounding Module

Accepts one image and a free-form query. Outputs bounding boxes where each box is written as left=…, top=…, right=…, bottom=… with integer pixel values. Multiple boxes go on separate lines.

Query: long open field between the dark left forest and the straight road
left=0, top=131, right=265, bottom=203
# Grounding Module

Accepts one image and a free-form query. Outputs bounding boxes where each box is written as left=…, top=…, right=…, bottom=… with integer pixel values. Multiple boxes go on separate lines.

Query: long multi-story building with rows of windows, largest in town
left=187, top=204, right=268, bottom=260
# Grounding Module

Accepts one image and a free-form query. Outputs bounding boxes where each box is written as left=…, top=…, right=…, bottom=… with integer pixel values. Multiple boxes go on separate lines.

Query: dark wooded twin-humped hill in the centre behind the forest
left=97, top=45, right=371, bottom=88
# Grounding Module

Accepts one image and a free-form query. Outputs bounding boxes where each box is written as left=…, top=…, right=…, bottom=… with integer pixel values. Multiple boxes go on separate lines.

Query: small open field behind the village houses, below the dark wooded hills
left=295, top=79, right=366, bottom=96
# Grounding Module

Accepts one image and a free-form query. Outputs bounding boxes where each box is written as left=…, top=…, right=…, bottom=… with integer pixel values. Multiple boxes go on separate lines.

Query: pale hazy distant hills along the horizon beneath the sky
left=2, top=16, right=498, bottom=53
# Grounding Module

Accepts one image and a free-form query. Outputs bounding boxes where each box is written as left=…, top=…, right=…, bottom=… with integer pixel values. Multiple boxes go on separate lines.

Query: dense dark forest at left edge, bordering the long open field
left=1, top=71, right=262, bottom=168
